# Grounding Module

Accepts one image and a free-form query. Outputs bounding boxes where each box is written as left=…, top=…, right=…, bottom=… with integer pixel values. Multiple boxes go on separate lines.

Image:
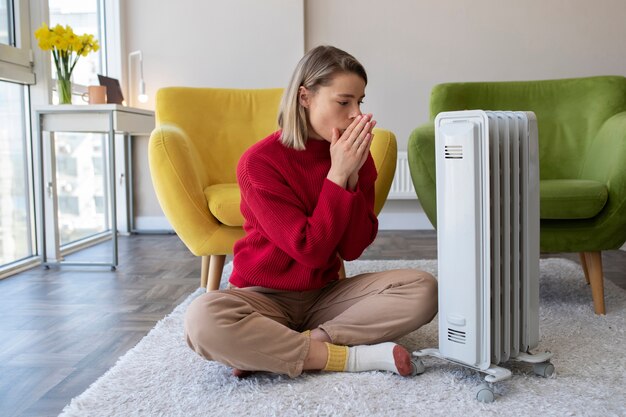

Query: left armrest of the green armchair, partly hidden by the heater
left=407, top=122, right=437, bottom=228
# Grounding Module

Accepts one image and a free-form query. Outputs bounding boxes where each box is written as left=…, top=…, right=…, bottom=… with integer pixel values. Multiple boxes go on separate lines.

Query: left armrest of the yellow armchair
left=148, top=124, right=219, bottom=256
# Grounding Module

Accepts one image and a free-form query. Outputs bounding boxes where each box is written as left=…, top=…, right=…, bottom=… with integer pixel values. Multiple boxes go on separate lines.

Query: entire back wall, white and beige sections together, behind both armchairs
left=121, top=0, right=626, bottom=228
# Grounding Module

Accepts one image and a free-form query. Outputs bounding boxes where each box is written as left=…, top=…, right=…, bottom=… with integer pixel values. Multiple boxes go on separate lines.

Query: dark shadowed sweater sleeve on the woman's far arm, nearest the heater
left=338, top=155, right=378, bottom=261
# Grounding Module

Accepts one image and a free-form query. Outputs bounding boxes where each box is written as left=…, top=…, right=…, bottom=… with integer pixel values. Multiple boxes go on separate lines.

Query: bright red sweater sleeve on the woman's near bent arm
left=238, top=153, right=358, bottom=268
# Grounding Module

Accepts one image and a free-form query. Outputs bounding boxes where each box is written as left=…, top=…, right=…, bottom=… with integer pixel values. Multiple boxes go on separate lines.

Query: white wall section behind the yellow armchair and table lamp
left=121, top=0, right=304, bottom=229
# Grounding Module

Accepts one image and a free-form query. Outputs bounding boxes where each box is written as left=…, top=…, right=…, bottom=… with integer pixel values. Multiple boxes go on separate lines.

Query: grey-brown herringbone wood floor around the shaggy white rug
left=0, top=231, right=626, bottom=417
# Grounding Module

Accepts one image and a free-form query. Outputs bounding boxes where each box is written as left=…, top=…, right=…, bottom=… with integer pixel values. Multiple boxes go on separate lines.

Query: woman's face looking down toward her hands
left=299, top=72, right=365, bottom=142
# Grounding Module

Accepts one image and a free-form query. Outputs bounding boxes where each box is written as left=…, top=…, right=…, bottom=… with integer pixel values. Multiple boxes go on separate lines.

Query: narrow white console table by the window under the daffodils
left=34, top=104, right=154, bottom=269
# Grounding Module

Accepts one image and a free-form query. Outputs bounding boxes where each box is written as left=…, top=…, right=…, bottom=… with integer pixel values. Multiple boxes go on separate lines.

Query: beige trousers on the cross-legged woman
left=185, top=269, right=437, bottom=377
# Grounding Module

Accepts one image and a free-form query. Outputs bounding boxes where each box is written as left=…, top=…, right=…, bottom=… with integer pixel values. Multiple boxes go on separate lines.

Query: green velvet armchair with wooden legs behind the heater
left=407, top=76, right=626, bottom=314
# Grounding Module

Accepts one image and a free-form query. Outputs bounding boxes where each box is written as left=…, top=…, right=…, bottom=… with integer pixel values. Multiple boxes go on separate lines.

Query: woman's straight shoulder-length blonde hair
left=278, top=46, right=367, bottom=150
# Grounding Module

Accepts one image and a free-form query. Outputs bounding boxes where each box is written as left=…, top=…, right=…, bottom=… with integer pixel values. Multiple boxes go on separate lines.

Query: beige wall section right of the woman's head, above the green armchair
left=305, top=0, right=626, bottom=149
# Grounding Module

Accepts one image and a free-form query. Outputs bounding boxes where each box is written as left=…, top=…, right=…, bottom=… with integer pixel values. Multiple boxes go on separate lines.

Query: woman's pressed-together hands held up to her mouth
left=327, top=114, right=376, bottom=189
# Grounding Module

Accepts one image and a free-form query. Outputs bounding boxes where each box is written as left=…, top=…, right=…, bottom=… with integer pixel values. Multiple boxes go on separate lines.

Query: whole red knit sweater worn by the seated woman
left=230, top=132, right=378, bottom=291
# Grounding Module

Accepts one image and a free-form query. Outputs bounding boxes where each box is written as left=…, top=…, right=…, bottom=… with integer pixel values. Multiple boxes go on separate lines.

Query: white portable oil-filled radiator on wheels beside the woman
left=414, top=110, right=554, bottom=402
